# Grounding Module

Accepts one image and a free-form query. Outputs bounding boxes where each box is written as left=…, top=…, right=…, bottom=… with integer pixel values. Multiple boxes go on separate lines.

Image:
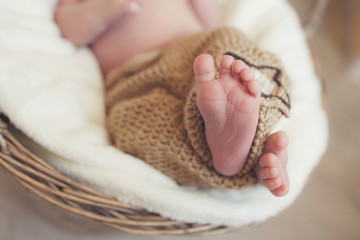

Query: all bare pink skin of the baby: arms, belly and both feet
left=55, top=0, right=289, bottom=196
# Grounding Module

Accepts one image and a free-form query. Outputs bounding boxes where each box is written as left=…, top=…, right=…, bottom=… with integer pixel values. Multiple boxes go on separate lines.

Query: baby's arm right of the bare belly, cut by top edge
left=189, top=0, right=222, bottom=29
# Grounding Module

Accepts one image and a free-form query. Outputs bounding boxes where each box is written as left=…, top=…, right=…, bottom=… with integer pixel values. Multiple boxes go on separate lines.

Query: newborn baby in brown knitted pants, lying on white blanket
left=55, top=0, right=290, bottom=196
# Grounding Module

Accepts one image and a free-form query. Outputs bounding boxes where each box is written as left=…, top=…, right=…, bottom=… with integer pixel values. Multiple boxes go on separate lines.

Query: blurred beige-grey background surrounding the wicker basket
left=0, top=0, right=360, bottom=240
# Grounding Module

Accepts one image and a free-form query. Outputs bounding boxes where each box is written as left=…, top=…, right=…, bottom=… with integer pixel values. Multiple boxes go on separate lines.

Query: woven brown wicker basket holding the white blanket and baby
left=0, top=0, right=328, bottom=235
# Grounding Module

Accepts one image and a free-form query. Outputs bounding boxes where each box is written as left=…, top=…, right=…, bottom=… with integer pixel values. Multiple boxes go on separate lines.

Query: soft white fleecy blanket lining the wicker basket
left=0, top=0, right=327, bottom=226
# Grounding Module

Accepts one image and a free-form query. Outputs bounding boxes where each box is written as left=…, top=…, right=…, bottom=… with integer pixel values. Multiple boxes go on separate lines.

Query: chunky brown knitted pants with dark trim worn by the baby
left=105, top=28, right=290, bottom=188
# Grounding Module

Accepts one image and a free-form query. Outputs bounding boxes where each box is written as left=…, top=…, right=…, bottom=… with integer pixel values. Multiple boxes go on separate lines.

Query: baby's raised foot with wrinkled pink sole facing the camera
left=194, top=54, right=261, bottom=176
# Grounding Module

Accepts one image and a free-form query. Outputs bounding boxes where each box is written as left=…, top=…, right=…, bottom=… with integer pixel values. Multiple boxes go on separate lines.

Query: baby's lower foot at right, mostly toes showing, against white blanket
left=255, top=132, right=289, bottom=197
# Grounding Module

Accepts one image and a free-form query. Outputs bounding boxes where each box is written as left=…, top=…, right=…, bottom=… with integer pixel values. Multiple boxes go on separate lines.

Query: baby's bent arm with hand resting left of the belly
left=55, top=0, right=140, bottom=46
